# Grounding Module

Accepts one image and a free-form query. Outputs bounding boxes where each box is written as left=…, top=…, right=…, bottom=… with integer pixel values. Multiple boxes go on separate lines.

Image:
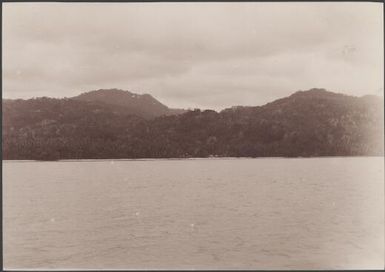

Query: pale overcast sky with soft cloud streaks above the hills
left=3, top=2, right=384, bottom=109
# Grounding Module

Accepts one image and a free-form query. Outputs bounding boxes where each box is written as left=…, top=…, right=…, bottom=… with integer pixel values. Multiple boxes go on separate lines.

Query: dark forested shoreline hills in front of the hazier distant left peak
left=3, top=89, right=384, bottom=160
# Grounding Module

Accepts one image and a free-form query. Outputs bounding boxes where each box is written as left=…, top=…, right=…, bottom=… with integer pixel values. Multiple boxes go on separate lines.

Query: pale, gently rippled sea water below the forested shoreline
left=3, top=158, right=384, bottom=269
